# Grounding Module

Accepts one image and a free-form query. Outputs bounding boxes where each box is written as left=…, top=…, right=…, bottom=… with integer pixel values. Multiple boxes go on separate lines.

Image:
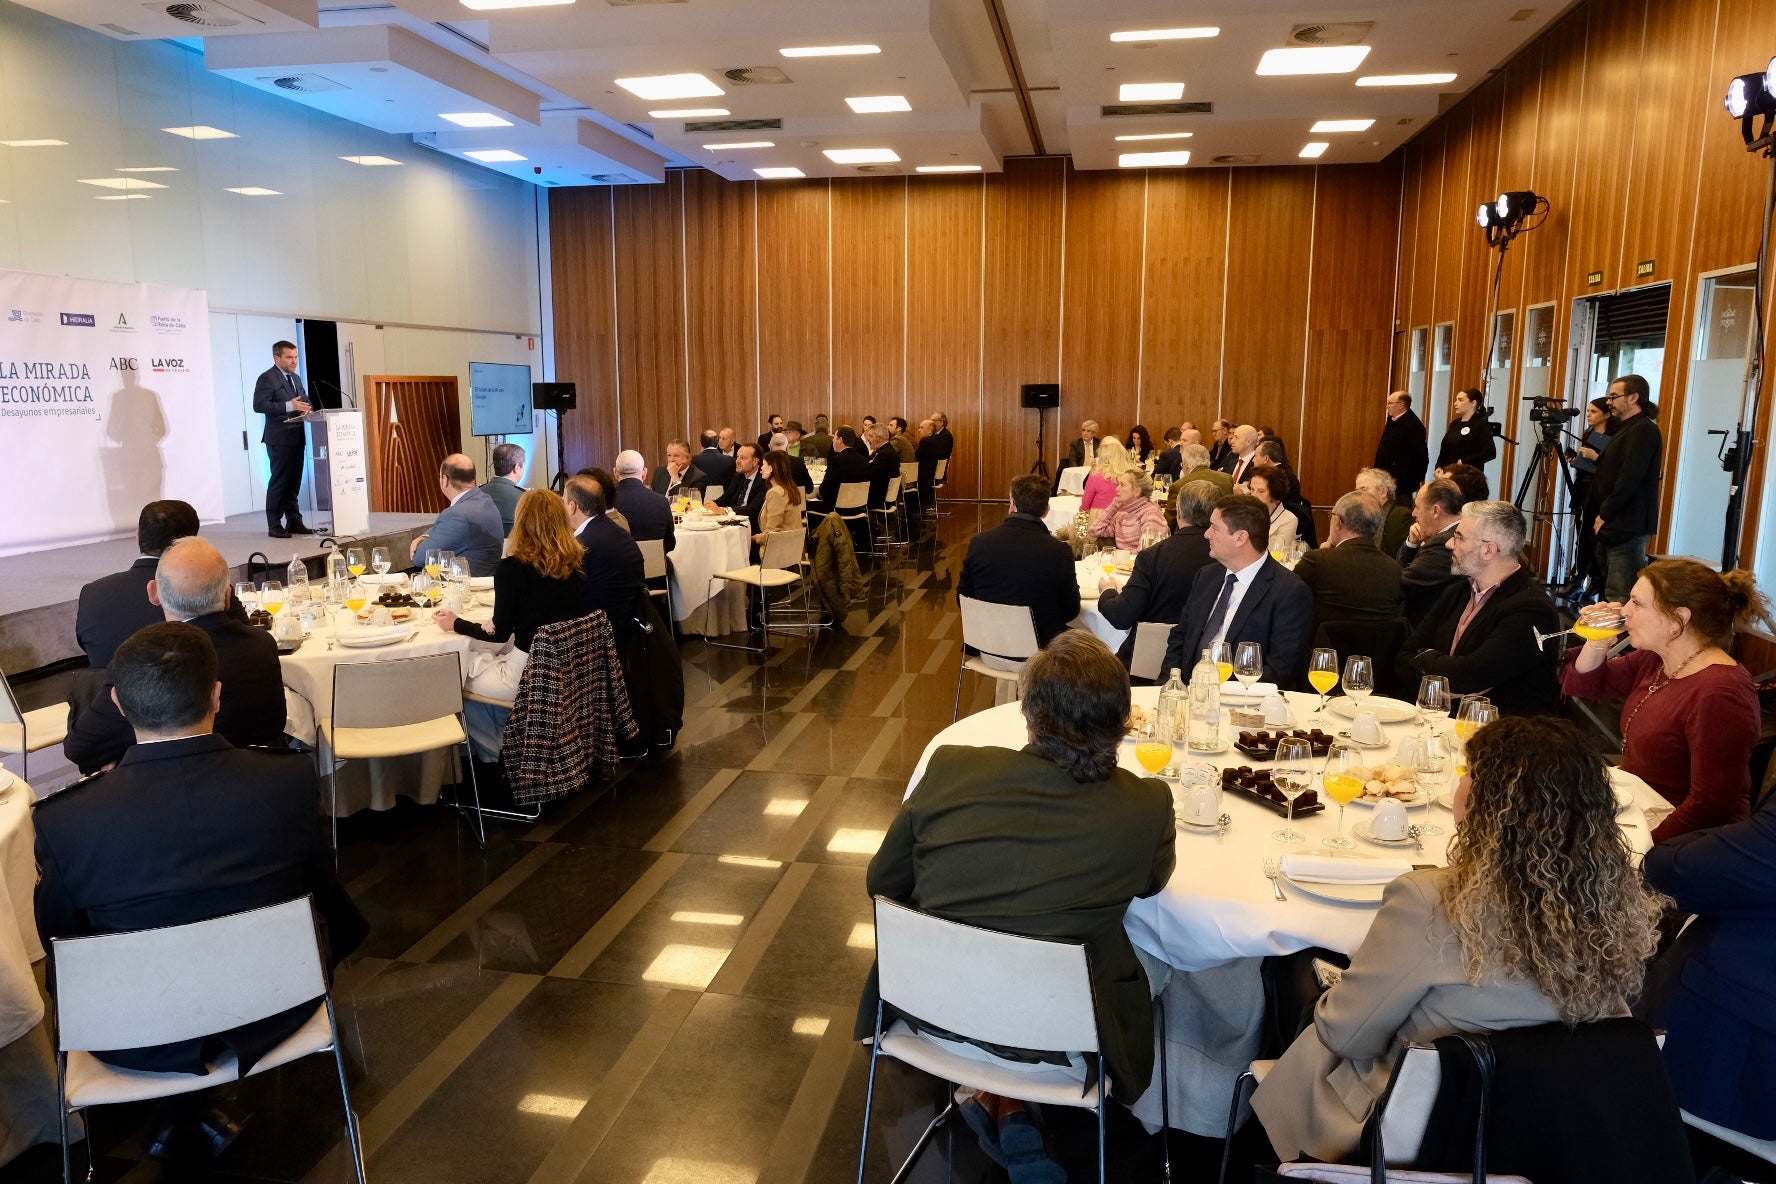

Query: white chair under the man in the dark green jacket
left=858, top=896, right=1170, bottom=1184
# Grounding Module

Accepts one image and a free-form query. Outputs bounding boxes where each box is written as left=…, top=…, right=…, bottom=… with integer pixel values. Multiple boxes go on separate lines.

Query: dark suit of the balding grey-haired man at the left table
left=62, top=612, right=284, bottom=772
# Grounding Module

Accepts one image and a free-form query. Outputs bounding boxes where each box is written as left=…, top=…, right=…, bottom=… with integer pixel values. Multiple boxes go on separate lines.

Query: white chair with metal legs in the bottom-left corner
left=50, top=896, right=364, bottom=1184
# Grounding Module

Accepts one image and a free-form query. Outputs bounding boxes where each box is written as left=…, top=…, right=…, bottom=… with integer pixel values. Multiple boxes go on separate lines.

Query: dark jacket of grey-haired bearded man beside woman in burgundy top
left=1398, top=568, right=1559, bottom=715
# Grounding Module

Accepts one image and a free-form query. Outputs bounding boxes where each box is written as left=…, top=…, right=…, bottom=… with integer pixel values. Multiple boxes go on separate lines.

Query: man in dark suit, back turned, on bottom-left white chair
left=32, top=621, right=369, bottom=1159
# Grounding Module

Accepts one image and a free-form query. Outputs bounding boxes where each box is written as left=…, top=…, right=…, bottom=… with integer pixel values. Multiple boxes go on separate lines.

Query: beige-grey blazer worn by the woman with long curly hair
left=1252, top=868, right=1559, bottom=1163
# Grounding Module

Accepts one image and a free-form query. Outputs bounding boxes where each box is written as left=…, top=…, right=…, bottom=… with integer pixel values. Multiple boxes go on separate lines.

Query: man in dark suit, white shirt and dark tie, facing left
left=1165, top=493, right=1314, bottom=691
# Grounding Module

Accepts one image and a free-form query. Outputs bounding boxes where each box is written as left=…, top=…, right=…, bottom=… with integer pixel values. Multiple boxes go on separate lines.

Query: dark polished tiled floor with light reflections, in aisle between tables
left=0, top=506, right=1250, bottom=1184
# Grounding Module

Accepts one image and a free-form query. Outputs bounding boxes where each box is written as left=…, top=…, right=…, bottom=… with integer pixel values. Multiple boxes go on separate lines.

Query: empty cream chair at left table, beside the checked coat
left=316, top=651, right=490, bottom=850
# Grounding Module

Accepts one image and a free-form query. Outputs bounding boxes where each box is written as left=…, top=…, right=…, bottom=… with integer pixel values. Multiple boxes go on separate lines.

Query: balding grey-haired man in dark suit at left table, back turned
left=62, top=538, right=284, bottom=772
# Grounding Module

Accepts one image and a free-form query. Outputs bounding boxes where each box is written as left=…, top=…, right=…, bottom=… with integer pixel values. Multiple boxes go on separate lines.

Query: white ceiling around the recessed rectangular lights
left=20, top=0, right=1574, bottom=185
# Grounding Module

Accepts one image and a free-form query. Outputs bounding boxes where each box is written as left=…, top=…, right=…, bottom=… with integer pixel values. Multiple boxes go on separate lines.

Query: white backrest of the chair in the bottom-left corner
left=50, top=896, right=327, bottom=1053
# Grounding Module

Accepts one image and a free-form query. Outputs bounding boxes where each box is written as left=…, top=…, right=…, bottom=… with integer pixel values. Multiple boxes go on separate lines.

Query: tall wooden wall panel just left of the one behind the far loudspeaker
left=909, top=176, right=994, bottom=499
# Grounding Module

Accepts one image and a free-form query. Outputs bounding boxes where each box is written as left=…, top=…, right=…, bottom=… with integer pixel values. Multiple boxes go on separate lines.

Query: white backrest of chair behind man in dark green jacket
left=876, top=896, right=1098, bottom=1053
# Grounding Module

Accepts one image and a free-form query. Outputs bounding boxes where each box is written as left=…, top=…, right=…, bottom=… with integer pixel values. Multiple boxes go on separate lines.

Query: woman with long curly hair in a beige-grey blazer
left=1252, top=719, right=1659, bottom=1163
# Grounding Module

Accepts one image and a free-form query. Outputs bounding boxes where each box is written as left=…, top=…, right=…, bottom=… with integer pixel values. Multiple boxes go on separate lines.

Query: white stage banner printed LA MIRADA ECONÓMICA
left=0, top=270, right=224, bottom=556
